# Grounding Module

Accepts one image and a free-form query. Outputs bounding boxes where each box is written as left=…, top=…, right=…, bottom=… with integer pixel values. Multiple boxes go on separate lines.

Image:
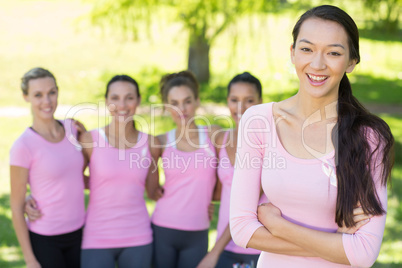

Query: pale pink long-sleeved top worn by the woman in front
left=230, top=103, right=387, bottom=268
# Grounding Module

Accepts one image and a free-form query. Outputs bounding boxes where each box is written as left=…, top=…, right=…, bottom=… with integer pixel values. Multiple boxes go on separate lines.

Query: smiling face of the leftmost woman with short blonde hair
left=23, top=77, right=58, bottom=120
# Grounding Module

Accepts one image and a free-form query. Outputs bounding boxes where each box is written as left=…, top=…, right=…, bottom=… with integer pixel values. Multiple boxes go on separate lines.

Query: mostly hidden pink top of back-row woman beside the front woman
left=217, top=132, right=268, bottom=255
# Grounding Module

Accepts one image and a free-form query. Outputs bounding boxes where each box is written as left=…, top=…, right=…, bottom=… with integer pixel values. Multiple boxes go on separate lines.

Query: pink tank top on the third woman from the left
left=152, top=127, right=218, bottom=231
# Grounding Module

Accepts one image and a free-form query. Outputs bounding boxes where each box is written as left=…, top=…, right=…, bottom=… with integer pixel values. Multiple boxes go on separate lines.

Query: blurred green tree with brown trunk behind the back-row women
left=87, top=0, right=280, bottom=82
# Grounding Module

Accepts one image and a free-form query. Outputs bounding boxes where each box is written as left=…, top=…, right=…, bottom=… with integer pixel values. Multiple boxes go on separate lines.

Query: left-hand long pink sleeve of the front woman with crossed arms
left=230, top=104, right=270, bottom=248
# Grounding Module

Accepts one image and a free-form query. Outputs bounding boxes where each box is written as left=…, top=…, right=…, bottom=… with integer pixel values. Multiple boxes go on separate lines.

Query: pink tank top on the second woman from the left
left=82, top=129, right=152, bottom=249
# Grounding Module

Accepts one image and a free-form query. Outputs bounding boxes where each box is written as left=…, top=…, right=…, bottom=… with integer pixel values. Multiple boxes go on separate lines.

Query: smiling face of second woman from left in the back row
left=106, top=81, right=141, bottom=121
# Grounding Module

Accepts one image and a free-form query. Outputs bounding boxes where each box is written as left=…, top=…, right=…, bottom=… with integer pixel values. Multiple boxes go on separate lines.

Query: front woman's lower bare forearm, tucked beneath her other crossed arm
left=247, top=227, right=317, bottom=257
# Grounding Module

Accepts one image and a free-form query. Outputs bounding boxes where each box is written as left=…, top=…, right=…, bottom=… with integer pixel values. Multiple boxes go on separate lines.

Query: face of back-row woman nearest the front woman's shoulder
left=227, top=82, right=261, bottom=125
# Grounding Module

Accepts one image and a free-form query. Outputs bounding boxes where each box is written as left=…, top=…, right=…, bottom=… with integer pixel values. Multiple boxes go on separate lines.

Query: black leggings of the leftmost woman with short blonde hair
left=29, top=228, right=82, bottom=268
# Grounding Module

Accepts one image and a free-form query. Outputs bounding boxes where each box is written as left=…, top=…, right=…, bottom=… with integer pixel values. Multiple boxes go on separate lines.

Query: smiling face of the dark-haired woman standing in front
left=291, top=18, right=356, bottom=100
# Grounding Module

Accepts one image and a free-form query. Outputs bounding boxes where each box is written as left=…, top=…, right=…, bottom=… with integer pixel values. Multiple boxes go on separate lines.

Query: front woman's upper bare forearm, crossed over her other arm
left=271, top=219, right=350, bottom=265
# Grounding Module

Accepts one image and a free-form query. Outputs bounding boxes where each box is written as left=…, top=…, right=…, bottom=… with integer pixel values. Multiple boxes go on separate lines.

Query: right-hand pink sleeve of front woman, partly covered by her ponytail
left=342, top=131, right=387, bottom=267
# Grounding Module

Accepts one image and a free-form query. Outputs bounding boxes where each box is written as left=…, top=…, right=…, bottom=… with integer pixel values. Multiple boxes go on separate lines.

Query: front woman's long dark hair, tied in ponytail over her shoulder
left=293, top=5, right=394, bottom=227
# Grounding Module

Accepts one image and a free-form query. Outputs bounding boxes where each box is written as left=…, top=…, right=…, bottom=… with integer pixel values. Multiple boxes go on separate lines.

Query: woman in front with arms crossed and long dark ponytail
left=230, top=5, right=393, bottom=267
